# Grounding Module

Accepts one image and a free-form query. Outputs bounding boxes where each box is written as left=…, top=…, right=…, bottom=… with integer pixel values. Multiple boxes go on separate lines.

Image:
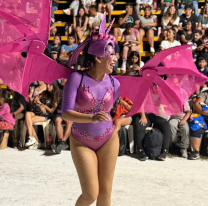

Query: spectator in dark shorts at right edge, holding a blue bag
left=189, top=91, right=208, bottom=160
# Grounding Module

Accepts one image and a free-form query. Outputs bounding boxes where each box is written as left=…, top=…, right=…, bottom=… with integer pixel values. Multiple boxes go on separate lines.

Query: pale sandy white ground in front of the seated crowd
left=0, top=148, right=208, bottom=206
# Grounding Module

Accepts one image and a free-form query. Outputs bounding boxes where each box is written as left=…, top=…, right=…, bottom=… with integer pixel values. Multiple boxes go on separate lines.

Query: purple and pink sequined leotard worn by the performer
left=62, top=72, right=120, bottom=150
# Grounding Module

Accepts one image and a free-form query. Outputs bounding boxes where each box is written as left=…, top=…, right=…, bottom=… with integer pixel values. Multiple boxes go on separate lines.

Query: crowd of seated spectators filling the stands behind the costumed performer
left=0, top=0, right=208, bottom=160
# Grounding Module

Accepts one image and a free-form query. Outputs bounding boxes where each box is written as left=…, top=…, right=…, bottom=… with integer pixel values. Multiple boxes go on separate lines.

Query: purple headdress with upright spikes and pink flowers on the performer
left=68, top=12, right=116, bottom=67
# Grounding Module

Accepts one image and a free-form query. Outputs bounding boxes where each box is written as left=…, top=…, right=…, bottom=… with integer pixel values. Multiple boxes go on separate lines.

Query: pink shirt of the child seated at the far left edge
left=0, top=103, right=15, bottom=124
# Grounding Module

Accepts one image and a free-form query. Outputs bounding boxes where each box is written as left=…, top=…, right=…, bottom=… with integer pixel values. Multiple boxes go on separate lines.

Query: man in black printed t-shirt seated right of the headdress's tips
left=113, top=4, right=139, bottom=43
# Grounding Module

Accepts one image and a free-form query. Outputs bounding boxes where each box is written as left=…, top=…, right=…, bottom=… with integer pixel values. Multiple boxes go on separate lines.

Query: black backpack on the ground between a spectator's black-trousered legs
left=143, top=129, right=164, bottom=160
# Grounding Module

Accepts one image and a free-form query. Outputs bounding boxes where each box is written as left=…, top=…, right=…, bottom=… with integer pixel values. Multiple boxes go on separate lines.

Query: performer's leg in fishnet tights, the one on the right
left=96, top=130, right=119, bottom=206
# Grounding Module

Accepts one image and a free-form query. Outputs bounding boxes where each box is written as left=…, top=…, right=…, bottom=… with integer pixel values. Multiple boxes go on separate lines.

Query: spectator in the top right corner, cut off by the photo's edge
left=198, top=2, right=208, bottom=35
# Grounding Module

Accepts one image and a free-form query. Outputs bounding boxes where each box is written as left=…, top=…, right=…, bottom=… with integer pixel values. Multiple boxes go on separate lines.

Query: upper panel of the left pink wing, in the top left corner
left=0, top=0, right=50, bottom=47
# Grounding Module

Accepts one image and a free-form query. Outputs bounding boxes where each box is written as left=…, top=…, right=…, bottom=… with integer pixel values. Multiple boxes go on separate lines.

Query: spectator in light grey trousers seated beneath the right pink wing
left=169, top=101, right=191, bottom=158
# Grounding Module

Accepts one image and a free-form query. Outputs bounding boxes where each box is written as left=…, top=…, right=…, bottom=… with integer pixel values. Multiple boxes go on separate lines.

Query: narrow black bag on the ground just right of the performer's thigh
left=118, top=127, right=128, bottom=156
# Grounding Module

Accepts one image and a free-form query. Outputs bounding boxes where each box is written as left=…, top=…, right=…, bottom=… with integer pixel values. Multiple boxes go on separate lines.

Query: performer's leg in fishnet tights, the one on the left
left=70, top=135, right=99, bottom=206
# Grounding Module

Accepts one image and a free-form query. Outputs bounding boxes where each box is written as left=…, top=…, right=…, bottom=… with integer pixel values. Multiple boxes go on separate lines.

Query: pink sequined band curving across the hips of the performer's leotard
left=72, top=124, right=114, bottom=142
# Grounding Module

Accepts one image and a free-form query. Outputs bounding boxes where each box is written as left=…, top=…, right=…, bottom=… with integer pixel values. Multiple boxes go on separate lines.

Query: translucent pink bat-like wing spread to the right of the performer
left=115, top=46, right=208, bottom=116
